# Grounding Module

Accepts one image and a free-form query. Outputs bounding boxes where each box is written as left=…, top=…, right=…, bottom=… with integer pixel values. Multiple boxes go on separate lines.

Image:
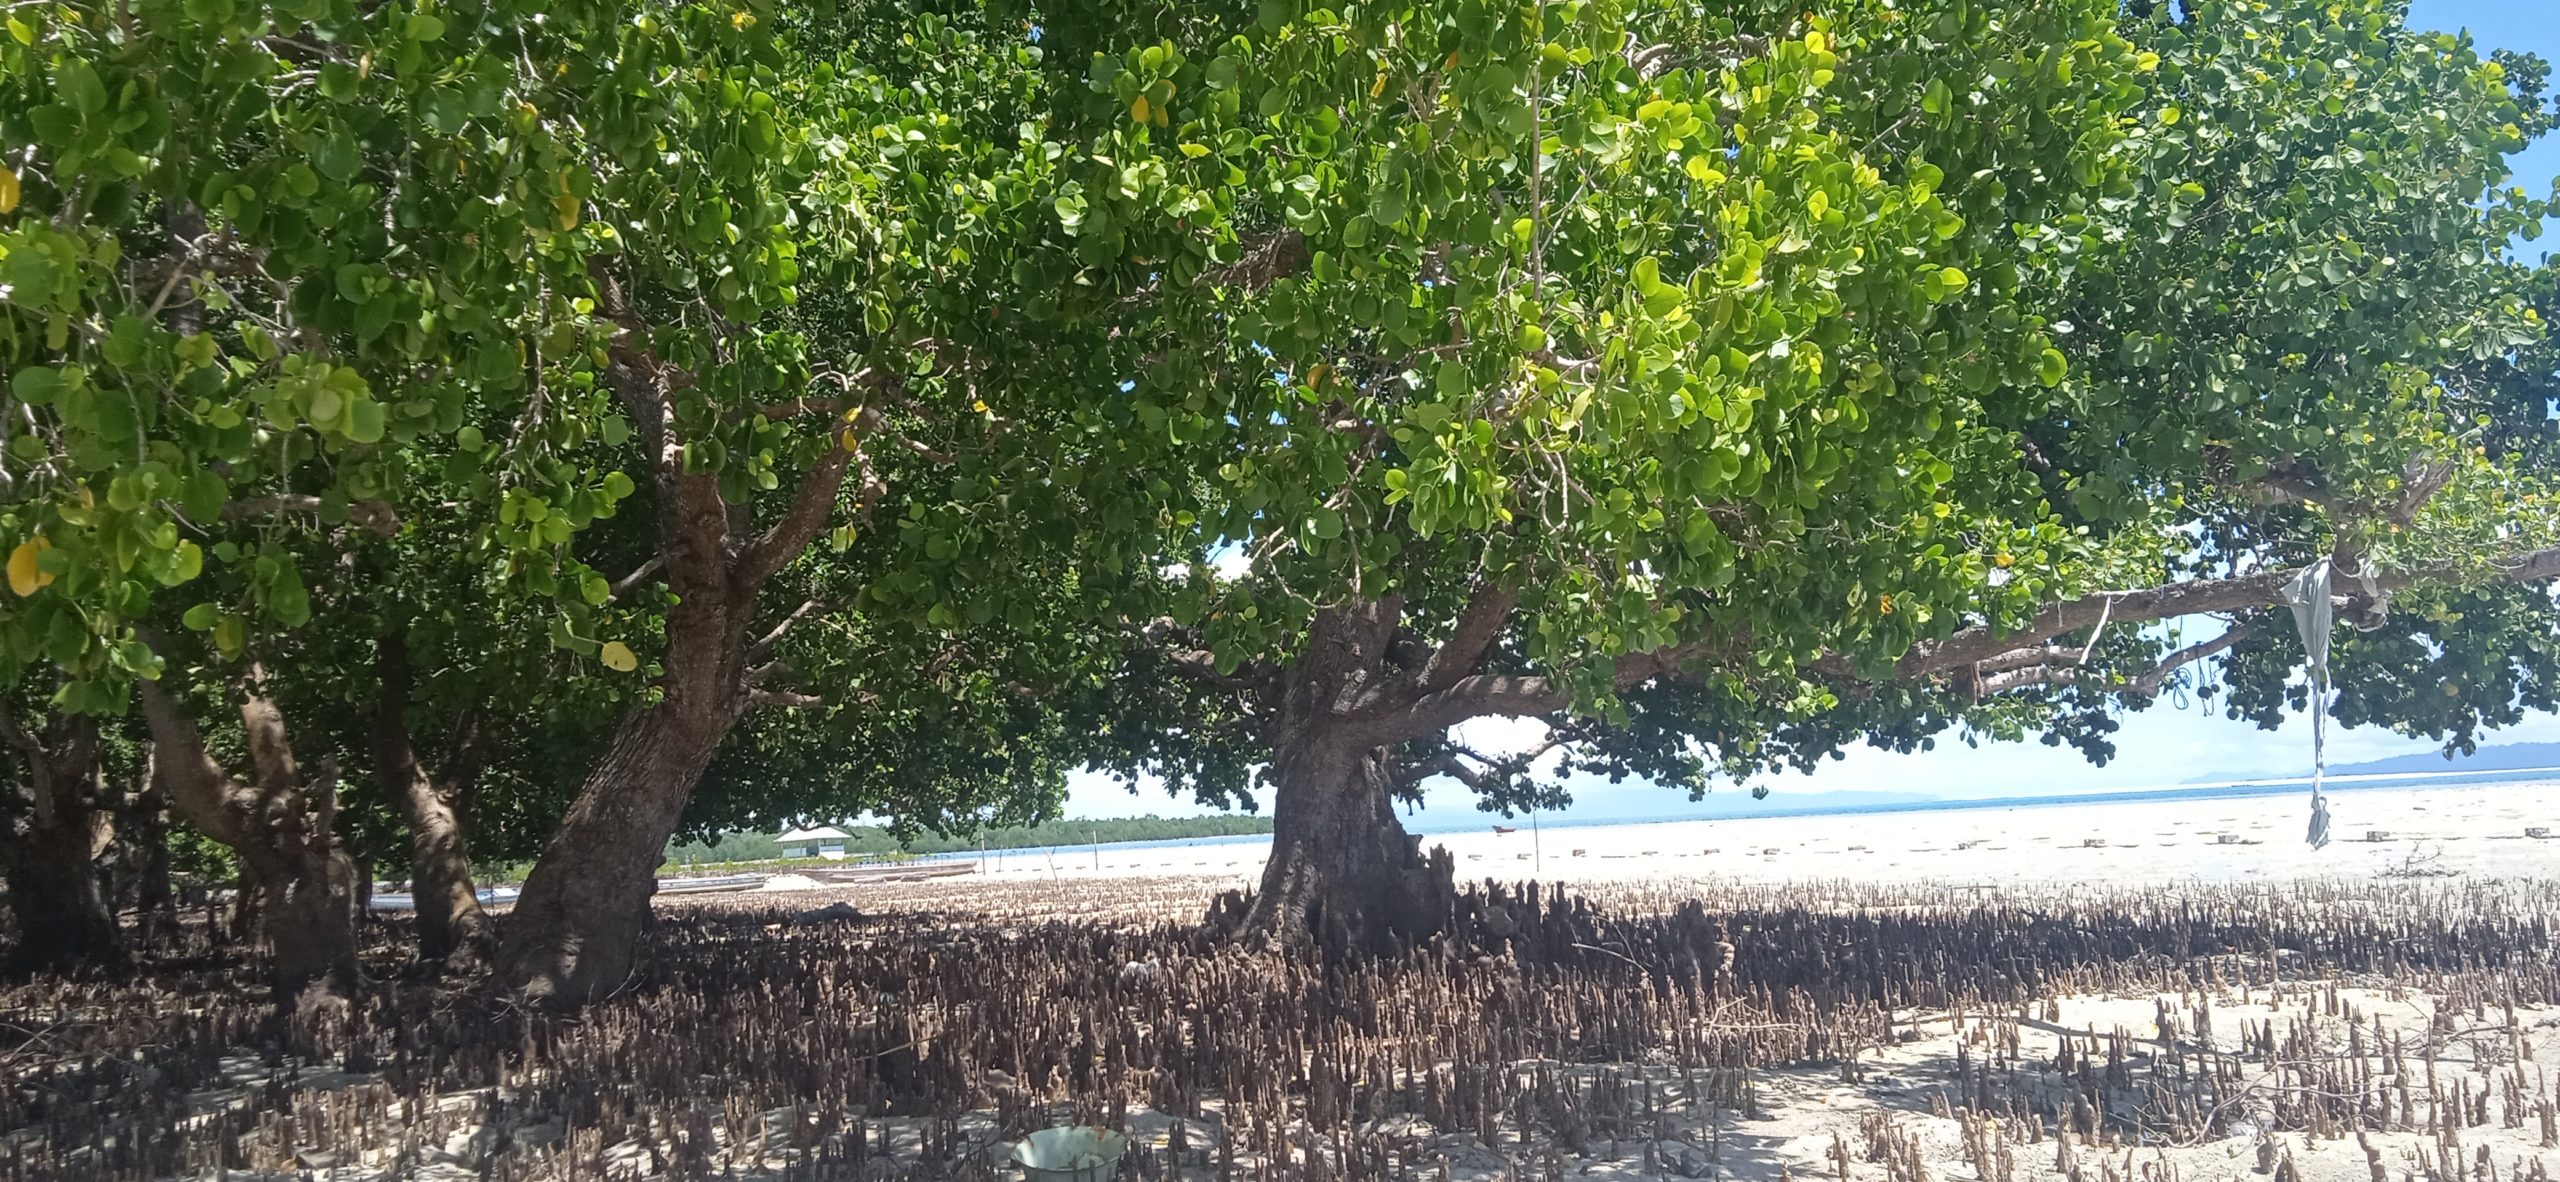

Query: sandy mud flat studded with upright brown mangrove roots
left=0, top=878, right=2560, bottom=1182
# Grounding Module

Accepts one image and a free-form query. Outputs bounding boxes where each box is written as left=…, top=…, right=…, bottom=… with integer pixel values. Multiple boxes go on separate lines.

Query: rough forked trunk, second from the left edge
left=141, top=665, right=358, bottom=1005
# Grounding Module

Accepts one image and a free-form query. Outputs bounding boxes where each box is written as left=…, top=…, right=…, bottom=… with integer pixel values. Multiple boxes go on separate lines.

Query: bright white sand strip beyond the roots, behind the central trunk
left=957, top=780, right=2560, bottom=885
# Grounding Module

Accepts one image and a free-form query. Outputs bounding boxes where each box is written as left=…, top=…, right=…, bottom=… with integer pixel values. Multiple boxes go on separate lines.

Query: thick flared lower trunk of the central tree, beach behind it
left=1244, top=742, right=1457, bottom=952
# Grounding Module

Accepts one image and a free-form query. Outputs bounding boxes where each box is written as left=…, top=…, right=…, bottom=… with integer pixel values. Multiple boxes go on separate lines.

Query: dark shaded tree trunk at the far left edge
left=0, top=716, right=125, bottom=972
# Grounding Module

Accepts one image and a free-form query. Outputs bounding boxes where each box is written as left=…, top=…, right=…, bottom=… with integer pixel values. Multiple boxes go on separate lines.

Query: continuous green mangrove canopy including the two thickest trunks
left=0, top=0, right=2560, bottom=1000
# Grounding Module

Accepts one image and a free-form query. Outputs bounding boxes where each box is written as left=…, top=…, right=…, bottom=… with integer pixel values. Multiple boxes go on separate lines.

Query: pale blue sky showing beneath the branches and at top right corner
left=1068, top=0, right=2560, bottom=824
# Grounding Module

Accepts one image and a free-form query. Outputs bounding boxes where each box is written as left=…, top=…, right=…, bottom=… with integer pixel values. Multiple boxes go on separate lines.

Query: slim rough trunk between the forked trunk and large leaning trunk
left=374, top=632, right=494, bottom=970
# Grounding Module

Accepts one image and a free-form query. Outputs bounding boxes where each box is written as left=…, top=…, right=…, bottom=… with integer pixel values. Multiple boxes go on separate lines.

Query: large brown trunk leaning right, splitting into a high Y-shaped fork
left=497, top=324, right=881, bottom=1005
